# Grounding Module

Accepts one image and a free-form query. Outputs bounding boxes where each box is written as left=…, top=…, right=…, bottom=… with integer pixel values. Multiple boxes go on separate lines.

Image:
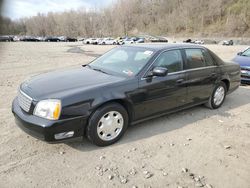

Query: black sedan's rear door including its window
left=184, top=48, right=217, bottom=103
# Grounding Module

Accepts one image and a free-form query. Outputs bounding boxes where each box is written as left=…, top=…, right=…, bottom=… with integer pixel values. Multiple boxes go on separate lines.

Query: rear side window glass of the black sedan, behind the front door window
left=185, top=49, right=214, bottom=69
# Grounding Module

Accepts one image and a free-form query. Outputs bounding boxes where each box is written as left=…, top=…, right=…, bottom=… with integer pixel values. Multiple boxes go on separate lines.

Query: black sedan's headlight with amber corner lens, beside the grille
left=33, top=99, right=61, bottom=120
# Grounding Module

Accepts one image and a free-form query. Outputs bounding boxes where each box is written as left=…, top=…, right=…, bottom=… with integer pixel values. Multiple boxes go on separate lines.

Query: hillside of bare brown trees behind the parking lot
left=0, top=0, right=250, bottom=37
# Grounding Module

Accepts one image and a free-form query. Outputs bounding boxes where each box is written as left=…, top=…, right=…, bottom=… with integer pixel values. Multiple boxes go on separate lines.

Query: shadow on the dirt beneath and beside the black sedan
left=65, top=87, right=250, bottom=152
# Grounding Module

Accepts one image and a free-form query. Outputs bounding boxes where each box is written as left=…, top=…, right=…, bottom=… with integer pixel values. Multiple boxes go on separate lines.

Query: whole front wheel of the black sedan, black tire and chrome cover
left=86, top=103, right=129, bottom=146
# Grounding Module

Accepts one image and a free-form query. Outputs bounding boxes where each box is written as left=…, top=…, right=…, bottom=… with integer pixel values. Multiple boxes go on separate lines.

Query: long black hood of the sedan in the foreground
left=20, top=67, right=126, bottom=101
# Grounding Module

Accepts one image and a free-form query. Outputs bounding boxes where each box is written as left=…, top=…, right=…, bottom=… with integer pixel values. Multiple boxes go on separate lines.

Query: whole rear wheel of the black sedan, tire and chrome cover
left=205, top=82, right=227, bottom=109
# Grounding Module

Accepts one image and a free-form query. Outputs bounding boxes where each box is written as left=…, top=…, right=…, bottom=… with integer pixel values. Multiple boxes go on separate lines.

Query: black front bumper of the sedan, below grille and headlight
left=12, top=98, right=87, bottom=142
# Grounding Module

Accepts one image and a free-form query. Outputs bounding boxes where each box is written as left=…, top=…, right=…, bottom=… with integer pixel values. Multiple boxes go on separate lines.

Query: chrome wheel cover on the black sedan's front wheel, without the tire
left=97, top=111, right=124, bottom=141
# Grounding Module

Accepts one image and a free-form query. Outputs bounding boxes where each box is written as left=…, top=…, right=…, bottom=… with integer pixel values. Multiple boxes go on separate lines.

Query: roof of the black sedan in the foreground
left=124, top=43, right=205, bottom=50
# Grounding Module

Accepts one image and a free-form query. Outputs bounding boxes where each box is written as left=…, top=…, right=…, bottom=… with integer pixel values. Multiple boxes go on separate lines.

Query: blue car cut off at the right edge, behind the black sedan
left=233, top=47, right=250, bottom=84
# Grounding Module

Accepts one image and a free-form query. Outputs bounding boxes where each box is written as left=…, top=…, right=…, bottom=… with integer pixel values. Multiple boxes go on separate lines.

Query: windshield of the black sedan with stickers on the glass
left=89, top=47, right=154, bottom=76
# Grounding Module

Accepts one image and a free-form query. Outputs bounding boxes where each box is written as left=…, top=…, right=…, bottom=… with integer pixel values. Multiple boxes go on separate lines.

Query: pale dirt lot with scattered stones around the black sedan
left=0, top=43, right=250, bottom=188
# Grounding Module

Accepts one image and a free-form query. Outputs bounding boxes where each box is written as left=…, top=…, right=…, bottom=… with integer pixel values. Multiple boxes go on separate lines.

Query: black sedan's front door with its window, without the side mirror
left=135, top=50, right=187, bottom=120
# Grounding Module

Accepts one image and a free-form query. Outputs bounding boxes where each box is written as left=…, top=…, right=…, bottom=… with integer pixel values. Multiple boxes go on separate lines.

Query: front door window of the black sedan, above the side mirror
left=154, top=50, right=183, bottom=73
